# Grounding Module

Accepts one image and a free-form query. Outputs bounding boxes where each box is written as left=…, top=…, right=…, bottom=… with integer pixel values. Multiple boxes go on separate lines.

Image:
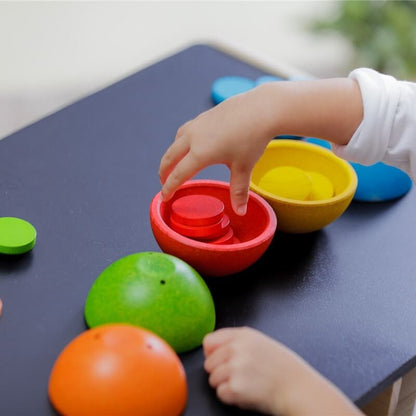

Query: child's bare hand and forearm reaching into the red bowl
left=159, top=78, right=363, bottom=215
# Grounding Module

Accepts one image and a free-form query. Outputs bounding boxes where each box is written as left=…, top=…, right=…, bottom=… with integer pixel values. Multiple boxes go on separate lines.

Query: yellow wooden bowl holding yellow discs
left=250, top=139, right=357, bottom=233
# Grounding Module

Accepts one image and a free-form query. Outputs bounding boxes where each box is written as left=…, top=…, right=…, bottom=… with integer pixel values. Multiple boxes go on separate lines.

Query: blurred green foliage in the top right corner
left=313, top=0, right=416, bottom=80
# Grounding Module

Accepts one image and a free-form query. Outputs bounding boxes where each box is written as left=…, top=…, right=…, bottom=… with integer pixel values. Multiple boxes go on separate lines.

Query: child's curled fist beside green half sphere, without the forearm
left=203, top=328, right=300, bottom=415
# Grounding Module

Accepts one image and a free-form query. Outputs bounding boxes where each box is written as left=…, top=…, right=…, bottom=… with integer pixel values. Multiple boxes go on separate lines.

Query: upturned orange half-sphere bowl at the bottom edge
left=49, top=324, right=187, bottom=416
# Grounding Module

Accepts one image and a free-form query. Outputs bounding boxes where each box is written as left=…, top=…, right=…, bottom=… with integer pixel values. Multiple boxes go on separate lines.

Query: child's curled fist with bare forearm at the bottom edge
left=203, top=328, right=361, bottom=416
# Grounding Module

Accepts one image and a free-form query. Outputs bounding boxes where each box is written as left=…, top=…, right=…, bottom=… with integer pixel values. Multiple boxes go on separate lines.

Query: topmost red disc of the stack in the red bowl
left=171, top=195, right=224, bottom=227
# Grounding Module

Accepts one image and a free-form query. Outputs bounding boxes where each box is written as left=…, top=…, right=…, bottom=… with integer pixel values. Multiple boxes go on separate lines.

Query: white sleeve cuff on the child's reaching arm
left=332, top=68, right=416, bottom=181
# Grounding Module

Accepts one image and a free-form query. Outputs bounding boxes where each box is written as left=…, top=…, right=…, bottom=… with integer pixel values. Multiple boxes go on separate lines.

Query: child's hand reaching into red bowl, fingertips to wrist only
left=159, top=87, right=273, bottom=215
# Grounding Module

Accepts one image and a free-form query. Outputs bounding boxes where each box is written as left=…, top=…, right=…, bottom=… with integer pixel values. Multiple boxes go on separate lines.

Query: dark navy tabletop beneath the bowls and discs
left=0, top=45, right=416, bottom=416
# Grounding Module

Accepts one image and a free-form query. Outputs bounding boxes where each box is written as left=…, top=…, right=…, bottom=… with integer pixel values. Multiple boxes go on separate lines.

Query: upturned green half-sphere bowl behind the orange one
left=85, top=252, right=215, bottom=353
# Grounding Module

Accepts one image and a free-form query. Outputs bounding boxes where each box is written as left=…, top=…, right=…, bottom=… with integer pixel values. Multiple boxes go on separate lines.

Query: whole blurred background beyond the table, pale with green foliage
left=0, top=0, right=416, bottom=138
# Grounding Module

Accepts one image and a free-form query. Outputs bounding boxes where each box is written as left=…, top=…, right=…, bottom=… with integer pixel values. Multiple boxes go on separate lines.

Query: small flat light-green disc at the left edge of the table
left=0, top=217, right=36, bottom=254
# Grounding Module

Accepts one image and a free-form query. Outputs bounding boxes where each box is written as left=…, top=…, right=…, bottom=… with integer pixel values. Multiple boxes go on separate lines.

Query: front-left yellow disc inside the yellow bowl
left=258, top=166, right=312, bottom=201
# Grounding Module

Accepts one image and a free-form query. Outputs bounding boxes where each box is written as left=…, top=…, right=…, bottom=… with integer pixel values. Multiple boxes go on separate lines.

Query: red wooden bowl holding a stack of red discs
left=150, top=180, right=277, bottom=276
